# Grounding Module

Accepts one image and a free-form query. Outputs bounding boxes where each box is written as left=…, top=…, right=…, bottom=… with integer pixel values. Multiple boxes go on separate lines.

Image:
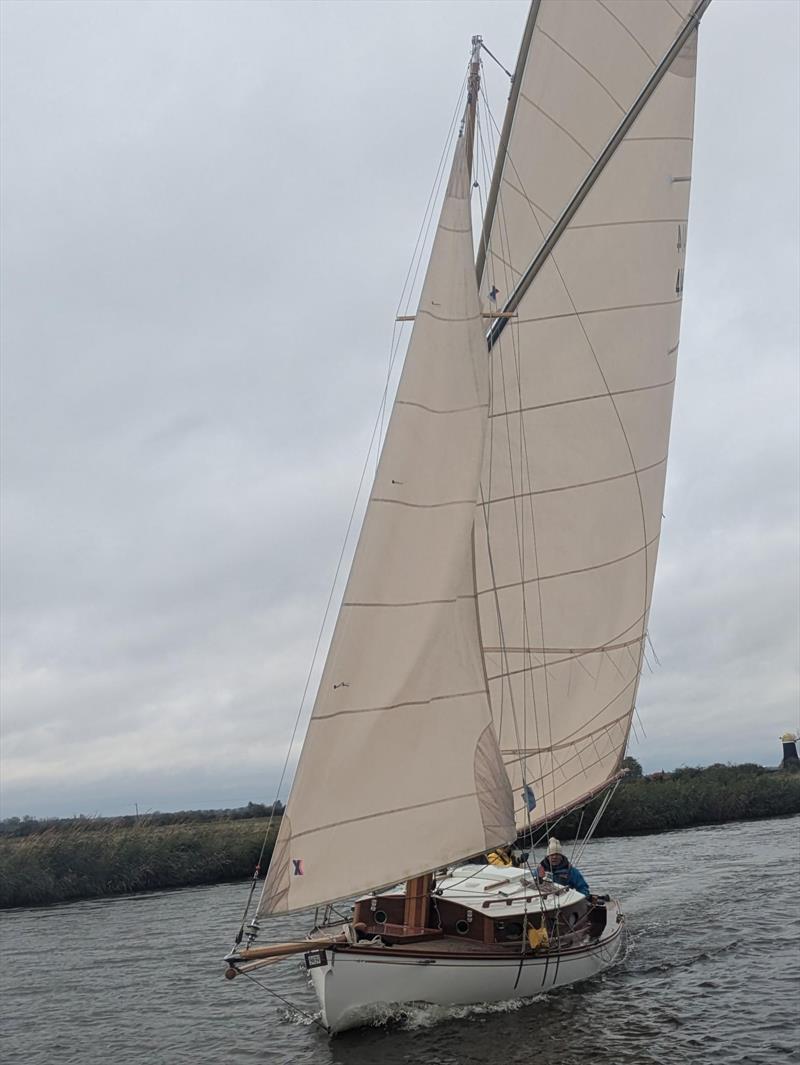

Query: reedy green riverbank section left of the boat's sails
left=0, top=818, right=277, bottom=907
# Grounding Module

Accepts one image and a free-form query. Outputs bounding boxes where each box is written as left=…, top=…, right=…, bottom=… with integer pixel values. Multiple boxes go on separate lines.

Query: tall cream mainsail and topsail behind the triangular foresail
left=475, top=0, right=697, bottom=828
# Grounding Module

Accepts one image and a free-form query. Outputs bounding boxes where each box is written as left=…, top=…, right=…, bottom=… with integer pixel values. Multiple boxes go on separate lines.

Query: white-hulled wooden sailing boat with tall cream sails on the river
left=226, top=0, right=709, bottom=1032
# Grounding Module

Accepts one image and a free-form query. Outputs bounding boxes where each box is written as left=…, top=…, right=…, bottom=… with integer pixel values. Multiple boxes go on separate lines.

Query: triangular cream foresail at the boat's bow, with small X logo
left=259, top=122, right=516, bottom=914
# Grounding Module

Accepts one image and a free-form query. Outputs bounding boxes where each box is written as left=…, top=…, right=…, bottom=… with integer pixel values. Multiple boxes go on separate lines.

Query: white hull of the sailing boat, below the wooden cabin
left=309, top=902, right=624, bottom=1032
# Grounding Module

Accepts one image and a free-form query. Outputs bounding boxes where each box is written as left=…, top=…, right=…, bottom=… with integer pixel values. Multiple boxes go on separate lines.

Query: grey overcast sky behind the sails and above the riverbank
left=0, top=0, right=800, bottom=816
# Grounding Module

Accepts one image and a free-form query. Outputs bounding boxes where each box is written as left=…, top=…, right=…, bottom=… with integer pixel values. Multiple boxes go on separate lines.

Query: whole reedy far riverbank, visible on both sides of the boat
left=0, top=763, right=800, bottom=908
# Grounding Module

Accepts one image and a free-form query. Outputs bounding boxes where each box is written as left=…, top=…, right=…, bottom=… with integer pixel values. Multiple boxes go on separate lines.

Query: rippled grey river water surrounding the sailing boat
left=0, top=817, right=800, bottom=1065
